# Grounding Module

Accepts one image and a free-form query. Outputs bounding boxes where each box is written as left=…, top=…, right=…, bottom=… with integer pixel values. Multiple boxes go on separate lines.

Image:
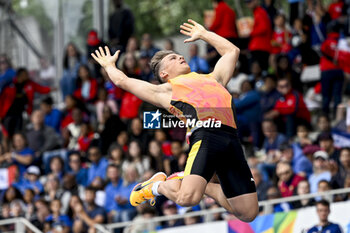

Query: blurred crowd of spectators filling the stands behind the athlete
left=0, top=0, right=350, bottom=232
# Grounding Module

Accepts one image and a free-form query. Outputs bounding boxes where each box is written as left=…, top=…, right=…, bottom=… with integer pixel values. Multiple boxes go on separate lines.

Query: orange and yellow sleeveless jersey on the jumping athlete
left=168, top=72, right=237, bottom=130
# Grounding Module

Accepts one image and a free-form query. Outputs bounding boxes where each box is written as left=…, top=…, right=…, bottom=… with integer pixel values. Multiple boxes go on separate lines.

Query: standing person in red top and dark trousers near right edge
left=320, top=25, right=344, bottom=115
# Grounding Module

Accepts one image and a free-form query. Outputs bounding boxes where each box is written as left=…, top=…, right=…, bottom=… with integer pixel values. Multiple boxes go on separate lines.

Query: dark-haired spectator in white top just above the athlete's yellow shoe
left=122, top=140, right=151, bottom=174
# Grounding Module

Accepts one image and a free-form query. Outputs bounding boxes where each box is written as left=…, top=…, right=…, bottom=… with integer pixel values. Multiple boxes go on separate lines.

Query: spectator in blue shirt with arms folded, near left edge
left=5, top=133, right=34, bottom=176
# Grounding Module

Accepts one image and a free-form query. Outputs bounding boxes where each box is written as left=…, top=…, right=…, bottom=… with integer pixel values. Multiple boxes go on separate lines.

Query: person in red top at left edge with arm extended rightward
left=0, top=68, right=52, bottom=137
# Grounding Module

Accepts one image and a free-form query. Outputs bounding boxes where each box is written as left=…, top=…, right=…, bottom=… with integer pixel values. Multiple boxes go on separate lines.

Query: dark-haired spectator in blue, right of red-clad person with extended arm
left=40, top=97, right=62, bottom=133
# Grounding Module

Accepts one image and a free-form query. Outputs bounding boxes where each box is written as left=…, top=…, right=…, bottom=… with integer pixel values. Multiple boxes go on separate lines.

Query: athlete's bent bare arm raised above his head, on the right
left=180, top=19, right=240, bottom=86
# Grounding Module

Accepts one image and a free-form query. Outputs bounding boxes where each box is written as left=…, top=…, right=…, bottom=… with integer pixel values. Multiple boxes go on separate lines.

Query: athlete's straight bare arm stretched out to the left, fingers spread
left=91, top=46, right=171, bottom=108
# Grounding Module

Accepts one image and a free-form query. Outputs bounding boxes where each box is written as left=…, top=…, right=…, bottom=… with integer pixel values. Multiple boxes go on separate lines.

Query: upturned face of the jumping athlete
left=159, top=53, right=191, bottom=81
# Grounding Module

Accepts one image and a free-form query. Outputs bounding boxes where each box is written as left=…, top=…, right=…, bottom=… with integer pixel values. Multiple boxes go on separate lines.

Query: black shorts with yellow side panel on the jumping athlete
left=184, top=126, right=256, bottom=198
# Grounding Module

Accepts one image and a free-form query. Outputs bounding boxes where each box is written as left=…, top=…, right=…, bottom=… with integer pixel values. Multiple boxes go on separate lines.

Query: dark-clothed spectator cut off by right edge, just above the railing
left=331, top=147, right=350, bottom=189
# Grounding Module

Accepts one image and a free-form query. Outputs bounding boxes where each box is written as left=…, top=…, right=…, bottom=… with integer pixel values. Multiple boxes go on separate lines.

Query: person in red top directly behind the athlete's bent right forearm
left=209, top=0, right=238, bottom=42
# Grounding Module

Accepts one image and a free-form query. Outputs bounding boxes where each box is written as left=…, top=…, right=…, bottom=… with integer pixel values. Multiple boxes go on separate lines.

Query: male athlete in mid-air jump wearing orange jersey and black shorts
left=91, top=20, right=258, bottom=222
